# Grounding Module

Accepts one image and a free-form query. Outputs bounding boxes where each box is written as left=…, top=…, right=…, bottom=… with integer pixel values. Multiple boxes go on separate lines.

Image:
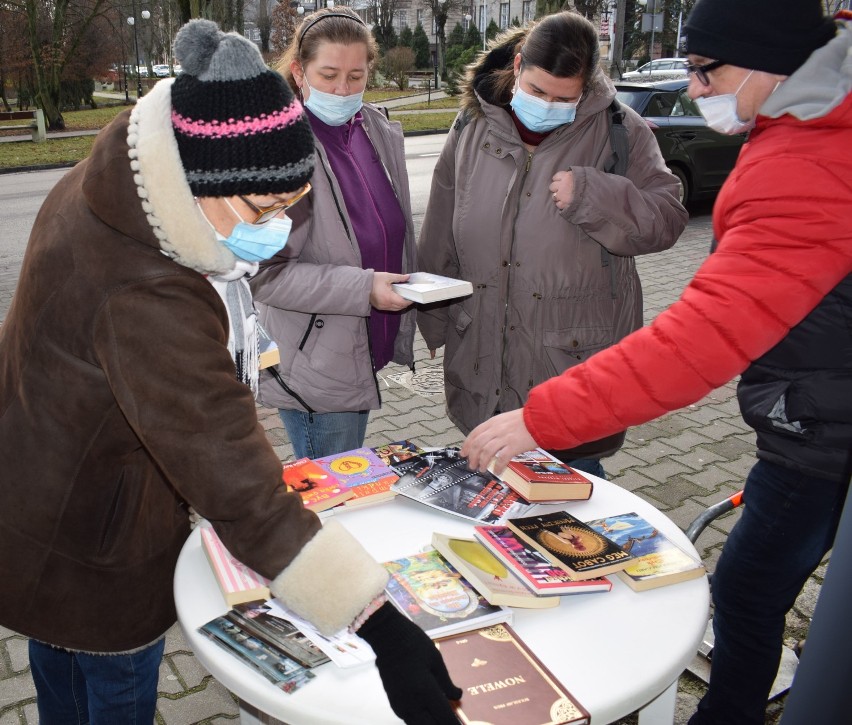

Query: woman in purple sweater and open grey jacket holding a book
left=252, top=7, right=416, bottom=458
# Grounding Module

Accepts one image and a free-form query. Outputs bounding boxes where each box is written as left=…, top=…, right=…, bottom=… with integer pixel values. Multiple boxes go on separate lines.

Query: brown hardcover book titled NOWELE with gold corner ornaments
left=436, top=624, right=591, bottom=725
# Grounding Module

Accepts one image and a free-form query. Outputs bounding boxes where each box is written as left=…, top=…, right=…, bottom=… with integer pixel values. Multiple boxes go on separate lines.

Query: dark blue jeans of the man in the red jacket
left=689, top=461, right=848, bottom=725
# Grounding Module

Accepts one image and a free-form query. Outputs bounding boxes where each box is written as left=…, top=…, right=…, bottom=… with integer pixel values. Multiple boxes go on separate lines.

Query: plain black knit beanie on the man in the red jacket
left=684, top=0, right=837, bottom=76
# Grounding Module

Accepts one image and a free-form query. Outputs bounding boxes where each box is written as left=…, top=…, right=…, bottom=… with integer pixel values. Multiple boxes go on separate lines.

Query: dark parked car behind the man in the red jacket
left=615, top=78, right=747, bottom=202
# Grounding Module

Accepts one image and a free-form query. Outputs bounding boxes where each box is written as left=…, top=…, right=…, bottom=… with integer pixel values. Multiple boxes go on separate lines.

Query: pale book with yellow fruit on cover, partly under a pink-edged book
left=432, top=531, right=559, bottom=609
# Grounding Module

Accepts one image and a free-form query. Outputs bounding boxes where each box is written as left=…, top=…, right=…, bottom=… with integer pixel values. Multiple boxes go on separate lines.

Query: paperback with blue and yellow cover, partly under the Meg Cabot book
left=586, top=512, right=705, bottom=592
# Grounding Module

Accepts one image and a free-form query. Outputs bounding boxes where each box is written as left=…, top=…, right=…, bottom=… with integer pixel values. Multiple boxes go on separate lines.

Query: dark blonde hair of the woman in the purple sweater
left=275, top=5, right=379, bottom=92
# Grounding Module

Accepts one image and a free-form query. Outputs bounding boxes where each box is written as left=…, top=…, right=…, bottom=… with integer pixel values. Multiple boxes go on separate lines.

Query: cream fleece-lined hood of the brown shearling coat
left=83, top=78, right=237, bottom=274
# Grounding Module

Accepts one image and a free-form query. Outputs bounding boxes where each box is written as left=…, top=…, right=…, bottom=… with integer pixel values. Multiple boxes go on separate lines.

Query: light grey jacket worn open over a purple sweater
left=251, top=105, right=417, bottom=413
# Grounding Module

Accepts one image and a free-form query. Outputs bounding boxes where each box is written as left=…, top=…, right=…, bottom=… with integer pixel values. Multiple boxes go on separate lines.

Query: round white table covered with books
left=174, top=478, right=709, bottom=725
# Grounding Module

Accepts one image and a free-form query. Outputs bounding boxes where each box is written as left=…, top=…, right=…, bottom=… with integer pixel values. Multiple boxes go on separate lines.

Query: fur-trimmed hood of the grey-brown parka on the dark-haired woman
left=459, top=28, right=615, bottom=120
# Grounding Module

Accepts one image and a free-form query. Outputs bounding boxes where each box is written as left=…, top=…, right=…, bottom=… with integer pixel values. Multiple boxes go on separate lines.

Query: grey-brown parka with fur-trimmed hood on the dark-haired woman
left=418, top=34, right=688, bottom=438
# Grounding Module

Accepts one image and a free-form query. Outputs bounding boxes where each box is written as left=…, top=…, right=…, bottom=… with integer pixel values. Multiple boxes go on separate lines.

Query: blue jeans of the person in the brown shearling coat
left=29, top=638, right=166, bottom=725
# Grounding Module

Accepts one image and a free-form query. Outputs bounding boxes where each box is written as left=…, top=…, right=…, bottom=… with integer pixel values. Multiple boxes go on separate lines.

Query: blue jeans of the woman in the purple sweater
left=278, top=408, right=370, bottom=458
